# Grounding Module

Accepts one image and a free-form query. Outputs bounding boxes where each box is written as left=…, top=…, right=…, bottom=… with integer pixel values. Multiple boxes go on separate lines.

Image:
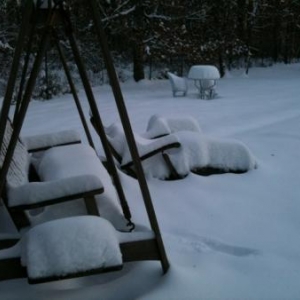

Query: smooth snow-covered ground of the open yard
left=0, top=64, right=300, bottom=300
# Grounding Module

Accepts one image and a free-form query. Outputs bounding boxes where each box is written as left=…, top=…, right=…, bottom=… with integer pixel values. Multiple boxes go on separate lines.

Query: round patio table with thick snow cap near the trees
left=188, top=65, right=220, bottom=99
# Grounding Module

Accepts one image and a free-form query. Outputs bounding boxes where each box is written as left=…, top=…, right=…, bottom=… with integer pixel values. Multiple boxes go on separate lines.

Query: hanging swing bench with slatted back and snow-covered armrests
left=1, top=122, right=104, bottom=229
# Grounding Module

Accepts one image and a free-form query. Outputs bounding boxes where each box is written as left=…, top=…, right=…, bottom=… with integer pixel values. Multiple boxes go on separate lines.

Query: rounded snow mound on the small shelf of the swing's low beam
left=21, top=216, right=123, bottom=283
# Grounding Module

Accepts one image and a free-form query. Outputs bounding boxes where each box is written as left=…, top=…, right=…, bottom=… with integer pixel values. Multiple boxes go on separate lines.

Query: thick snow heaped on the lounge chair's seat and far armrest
left=146, top=115, right=257, bottom=178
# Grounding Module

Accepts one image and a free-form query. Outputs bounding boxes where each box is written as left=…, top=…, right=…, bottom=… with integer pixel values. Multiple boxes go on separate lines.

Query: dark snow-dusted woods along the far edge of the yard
left=0, top=0, right=300, bottom=97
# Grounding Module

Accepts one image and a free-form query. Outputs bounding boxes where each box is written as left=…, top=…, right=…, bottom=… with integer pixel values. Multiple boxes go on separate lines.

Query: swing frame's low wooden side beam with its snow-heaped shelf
left=0, top=212, right=160, bottom=283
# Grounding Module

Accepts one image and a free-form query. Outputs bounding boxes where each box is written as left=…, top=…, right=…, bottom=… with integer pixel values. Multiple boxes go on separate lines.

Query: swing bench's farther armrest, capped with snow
left=22, top=130, right=81, bottom=152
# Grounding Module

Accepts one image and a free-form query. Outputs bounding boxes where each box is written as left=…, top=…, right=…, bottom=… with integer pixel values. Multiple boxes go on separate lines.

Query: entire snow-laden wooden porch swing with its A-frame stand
left=0, top=0, right=169, bottom=283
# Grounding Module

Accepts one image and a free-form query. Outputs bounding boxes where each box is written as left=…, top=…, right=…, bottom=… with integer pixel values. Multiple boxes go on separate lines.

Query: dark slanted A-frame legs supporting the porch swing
left=0, top=0, right=169, bottom=273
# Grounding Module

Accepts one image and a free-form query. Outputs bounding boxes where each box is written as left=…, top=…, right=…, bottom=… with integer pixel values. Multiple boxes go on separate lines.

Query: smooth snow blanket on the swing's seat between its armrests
left=35, top=144, right=128, bottom=230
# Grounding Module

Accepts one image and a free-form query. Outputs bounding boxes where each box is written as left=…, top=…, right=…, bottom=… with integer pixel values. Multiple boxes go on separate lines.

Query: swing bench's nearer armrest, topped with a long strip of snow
left=7, top=175, right=104, bottom=209
